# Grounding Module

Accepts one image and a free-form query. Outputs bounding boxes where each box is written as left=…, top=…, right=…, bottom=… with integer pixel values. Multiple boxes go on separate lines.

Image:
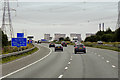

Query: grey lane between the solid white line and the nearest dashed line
left=5, top=45, right=71, bottom=78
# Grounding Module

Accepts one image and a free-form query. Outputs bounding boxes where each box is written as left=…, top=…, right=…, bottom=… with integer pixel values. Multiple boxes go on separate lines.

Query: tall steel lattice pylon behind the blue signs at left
left=1, top=0, right=14, bottom=38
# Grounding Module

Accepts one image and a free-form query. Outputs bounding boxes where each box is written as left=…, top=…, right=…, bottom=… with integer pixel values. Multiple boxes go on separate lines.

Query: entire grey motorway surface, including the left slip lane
left=2, top=44, right=118, bottom=78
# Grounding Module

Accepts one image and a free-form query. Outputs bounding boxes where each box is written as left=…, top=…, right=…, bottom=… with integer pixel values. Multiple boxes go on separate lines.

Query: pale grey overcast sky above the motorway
left=0, top=0, right=118, bottom=40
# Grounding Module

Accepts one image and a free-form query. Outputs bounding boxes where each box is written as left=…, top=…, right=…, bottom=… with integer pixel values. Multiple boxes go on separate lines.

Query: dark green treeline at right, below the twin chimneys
left=85, top=28, right=120, bottom=42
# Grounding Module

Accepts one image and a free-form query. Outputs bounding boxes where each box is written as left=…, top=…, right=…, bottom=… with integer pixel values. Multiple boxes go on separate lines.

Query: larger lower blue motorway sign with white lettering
left=12, top=38, right=27, bottom=47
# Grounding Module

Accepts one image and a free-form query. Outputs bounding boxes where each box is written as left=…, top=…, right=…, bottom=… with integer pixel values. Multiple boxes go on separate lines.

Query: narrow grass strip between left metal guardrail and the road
left=1, top=47, right=38, bottom=63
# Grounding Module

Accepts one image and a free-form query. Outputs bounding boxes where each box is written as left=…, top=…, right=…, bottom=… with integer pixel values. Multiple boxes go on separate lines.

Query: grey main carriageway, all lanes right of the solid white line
left=2, top=44, right=118, bottom=78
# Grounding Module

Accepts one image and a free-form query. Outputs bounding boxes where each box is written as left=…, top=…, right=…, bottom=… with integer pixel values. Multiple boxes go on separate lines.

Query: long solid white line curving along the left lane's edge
left=0, top=48, right=52, bottom=80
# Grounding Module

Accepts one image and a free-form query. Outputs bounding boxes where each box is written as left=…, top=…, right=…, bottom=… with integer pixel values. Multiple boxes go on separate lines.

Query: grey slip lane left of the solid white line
left=2, top=45, right=50, bottom=76
